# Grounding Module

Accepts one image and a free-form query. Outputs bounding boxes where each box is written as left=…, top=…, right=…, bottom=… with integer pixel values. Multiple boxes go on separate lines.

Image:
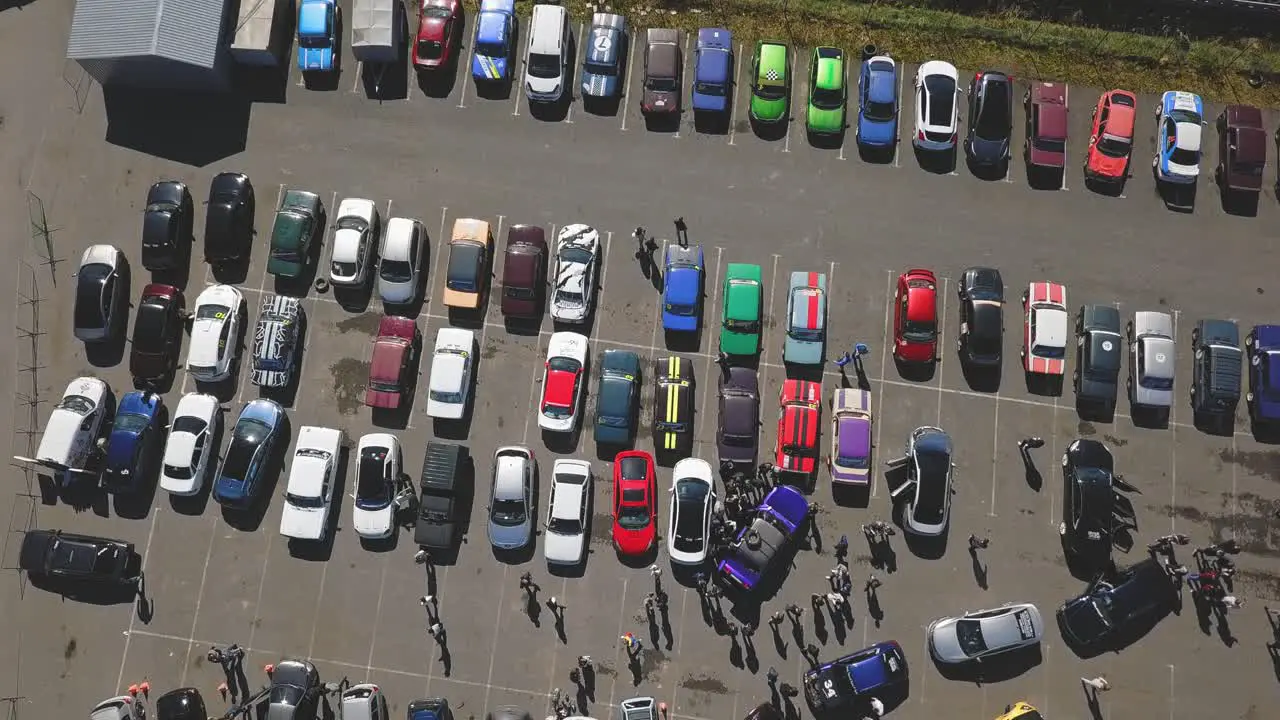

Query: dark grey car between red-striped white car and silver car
left=1071, top=305, right=1124, bottom=414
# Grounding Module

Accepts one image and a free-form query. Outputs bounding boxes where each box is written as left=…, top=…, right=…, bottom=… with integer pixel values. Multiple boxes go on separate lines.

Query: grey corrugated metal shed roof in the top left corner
left=67, top=0, right=227, bottom=68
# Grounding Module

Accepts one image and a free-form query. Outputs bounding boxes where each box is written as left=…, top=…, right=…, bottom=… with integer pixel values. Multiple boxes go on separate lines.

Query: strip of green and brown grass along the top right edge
left=468, top=0, right=1280, bottom=106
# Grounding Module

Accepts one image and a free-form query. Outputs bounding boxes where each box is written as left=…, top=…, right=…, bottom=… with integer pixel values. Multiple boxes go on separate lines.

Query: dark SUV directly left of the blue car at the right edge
left=1192, top=315, right=1244, bottom=427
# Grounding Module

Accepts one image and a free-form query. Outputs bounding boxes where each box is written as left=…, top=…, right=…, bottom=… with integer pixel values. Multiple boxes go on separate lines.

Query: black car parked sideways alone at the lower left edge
left=18, top=530, right=142, bottom=585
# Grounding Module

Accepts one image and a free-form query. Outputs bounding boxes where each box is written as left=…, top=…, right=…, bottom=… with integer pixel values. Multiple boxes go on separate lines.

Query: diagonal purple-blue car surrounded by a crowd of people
left=717, top=486, right=809, bottom=591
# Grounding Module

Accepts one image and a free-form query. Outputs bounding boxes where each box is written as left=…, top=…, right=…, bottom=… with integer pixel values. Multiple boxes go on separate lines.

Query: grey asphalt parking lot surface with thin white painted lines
left=0, top=4, right=1280, bottom=720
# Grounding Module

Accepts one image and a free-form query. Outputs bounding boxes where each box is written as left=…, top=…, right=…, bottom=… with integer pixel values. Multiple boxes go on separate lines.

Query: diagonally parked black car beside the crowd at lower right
left=1057, top=557, right=1178, bottom=650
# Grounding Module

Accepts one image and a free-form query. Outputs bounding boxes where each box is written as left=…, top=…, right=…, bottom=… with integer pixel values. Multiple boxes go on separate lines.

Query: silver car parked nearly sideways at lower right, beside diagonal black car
left=927, top=602, right=1044, bottom=665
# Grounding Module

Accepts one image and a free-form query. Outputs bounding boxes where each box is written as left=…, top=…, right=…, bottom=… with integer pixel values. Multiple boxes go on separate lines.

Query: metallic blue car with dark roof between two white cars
left=214, top=398, right=288, bottom=510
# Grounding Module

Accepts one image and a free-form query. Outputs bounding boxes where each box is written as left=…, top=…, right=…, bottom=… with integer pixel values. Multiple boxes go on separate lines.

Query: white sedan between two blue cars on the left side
left=160, top=392, right=223, bottom=496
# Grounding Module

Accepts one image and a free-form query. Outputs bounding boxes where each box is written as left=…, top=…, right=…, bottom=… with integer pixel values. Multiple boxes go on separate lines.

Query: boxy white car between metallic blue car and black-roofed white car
left=280, top=425, right=342, bottom=541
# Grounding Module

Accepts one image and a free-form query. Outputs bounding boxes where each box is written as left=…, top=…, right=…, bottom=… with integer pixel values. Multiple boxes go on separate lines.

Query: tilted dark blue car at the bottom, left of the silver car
left=804, top=641, right=908, bottom=717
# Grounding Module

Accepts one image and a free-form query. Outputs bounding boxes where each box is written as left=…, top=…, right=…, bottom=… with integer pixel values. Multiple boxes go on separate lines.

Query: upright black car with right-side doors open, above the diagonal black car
left=1057, top=438, right=1116, bottom=566
